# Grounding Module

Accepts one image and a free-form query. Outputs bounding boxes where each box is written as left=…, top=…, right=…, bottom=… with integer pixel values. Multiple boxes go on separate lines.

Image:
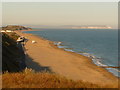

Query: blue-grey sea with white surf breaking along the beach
left=25, top=29, right=120, bottom=76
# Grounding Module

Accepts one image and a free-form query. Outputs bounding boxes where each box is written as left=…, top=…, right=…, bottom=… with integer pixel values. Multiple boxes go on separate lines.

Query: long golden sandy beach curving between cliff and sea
left=15, top=31, right=118, bottom=86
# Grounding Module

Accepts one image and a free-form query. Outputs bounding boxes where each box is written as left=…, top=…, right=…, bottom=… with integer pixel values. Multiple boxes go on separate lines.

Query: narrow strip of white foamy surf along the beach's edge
left=22, top=29, right=120, bottom=75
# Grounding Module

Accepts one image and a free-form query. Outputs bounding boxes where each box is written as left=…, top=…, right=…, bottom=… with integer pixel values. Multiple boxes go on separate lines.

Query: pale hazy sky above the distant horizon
left=2, top=2, right=118, bottom=28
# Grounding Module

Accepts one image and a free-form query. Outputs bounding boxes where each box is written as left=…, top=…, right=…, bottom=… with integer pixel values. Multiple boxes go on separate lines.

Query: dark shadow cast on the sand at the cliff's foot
left=25, top=55, right=53, bottom=73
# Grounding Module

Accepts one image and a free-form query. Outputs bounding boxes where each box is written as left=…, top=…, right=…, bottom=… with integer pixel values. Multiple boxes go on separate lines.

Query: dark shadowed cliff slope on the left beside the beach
left=2, top=33, right=26, bottom=72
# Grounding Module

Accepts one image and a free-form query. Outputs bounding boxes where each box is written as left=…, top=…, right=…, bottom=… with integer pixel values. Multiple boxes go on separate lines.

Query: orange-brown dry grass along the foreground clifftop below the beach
left=2, top=69, right=117, bottom=88
